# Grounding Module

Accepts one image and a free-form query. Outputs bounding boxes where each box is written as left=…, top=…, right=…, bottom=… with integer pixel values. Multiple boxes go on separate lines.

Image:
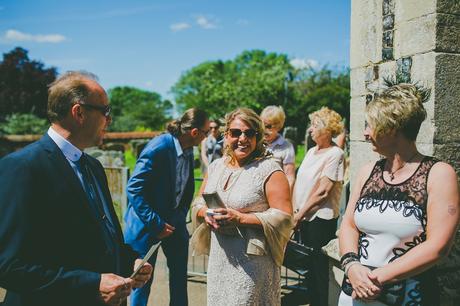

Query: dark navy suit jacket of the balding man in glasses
left=0, top=134, right=137, bottom=306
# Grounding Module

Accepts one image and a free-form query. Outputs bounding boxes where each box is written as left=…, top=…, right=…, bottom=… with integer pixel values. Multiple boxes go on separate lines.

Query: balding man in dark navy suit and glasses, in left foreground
left=0, top=72, right=153, bottom=306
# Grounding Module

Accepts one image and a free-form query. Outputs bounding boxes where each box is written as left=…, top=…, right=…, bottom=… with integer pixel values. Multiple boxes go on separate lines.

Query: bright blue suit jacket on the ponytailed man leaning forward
left=125, top=133, right=195, bottom=254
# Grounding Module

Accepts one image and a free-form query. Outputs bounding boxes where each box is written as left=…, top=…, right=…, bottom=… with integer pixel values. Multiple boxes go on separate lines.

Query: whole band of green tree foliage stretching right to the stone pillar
left=171, top=50, right=350, bottom=139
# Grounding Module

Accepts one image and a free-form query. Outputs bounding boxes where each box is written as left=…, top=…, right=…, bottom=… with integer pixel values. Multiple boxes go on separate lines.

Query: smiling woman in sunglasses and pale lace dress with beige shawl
left=192, top=108, right=292, bottom=306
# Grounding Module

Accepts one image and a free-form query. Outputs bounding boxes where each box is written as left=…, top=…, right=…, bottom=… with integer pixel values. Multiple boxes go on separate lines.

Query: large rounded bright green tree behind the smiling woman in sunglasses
left=171, top=50, right=292, bottom=116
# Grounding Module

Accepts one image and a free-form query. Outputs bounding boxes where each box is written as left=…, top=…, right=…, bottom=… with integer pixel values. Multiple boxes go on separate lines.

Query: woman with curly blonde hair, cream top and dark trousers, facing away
left=292, top=107, right=344, bottom=306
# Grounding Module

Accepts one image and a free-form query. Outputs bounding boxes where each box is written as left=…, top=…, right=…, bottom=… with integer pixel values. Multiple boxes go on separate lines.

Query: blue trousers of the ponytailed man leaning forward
left=130, top=224, right=189, bottom=306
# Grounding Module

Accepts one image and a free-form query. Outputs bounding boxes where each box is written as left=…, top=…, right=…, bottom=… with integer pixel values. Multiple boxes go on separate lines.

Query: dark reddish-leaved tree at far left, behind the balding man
left=0, top=47, right=57, bottom=121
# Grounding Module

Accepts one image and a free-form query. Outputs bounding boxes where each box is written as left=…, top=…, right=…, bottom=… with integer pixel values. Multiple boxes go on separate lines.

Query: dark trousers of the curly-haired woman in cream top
left=300, top=217, right=337, bottom=306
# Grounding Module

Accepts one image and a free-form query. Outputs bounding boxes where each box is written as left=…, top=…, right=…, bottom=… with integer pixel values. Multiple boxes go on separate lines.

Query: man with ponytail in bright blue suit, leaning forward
left=125, top=109, right=209, bottom=306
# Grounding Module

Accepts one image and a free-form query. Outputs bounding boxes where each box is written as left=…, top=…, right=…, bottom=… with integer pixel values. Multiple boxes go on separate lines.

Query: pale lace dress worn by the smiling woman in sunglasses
left=205, top=158, right=281, bottom=306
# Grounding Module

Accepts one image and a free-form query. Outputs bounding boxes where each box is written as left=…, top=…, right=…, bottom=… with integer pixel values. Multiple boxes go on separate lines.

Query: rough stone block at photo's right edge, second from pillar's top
left=436, top=14, right=460, bottom=53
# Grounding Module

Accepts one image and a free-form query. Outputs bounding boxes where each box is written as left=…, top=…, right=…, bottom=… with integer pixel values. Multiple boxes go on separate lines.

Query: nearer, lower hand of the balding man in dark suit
left=99, top=273, right=134, bottom=305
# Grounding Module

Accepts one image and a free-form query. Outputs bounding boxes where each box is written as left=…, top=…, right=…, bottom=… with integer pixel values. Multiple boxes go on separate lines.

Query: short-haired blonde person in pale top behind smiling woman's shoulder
left=260, top=105, right=295, bottom=188
